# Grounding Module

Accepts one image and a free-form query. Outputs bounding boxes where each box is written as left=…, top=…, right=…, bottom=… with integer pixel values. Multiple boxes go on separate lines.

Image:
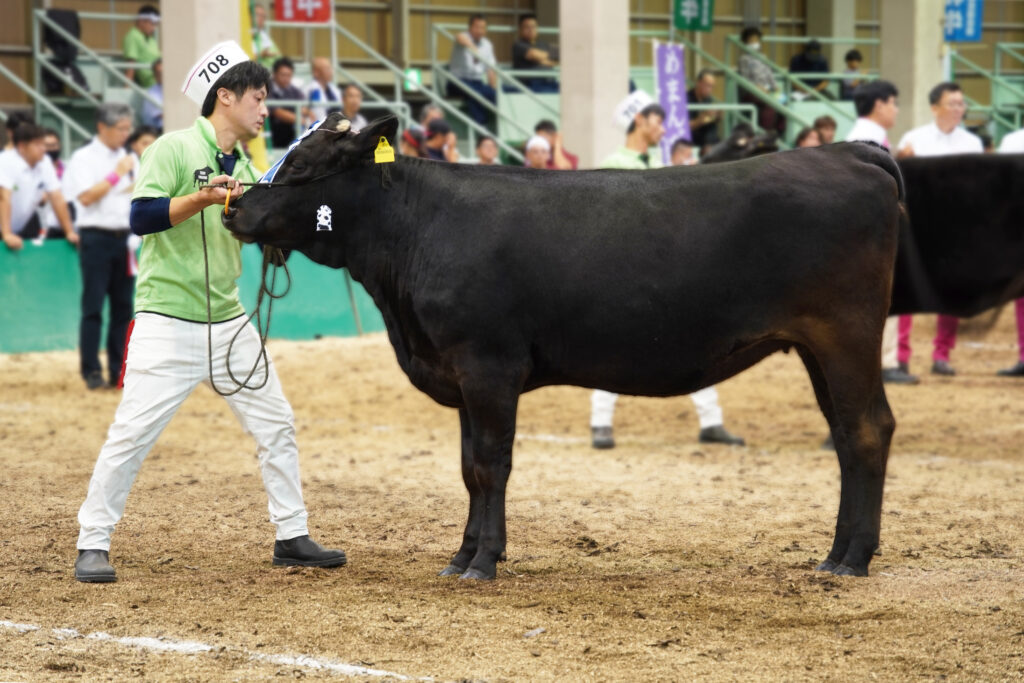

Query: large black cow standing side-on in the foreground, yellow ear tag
left=224, top=118, right=902, bottom=579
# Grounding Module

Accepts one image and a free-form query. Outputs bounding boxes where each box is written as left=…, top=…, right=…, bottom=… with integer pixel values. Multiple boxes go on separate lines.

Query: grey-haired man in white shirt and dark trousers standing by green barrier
left=63, top=102, right=135, bottom=389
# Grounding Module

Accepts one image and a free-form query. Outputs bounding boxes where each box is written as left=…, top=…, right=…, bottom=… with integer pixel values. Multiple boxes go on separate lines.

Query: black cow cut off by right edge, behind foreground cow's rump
left=892, top=154, right=1024, bottom=317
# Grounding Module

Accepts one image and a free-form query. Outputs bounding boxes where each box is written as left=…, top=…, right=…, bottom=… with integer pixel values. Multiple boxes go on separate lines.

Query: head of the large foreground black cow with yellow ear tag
left=222, top=114, right=398, bottom=264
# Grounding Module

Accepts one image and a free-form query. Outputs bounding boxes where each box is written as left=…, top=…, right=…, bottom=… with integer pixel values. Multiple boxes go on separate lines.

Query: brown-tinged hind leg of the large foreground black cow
left=801, top=339, right=896, bottom=577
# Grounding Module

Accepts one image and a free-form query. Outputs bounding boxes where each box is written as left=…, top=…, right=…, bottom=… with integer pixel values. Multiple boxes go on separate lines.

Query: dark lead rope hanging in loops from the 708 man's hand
left=200, top=182, right=292, bottom=397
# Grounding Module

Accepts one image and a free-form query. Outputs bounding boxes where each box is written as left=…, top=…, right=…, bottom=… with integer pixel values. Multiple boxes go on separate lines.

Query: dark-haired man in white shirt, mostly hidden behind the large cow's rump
left=846, top=79, right=919, bottom=384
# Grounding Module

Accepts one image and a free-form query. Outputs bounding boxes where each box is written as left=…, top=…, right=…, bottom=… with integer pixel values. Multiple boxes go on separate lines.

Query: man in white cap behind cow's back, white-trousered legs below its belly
left=590, top=90, right=743, bottom=449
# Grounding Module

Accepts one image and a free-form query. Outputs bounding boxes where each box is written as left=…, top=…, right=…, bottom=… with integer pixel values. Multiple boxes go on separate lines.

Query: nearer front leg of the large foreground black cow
left=453, top=375, right=520, bottom=579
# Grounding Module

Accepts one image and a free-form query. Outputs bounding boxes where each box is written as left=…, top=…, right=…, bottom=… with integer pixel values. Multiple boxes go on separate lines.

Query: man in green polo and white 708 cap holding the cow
left=75, top=42, right=346, bottom=583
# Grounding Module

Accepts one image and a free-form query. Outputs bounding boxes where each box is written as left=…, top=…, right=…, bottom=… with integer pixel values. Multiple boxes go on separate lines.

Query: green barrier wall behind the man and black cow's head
left=0, top=240, right=384, bottom=353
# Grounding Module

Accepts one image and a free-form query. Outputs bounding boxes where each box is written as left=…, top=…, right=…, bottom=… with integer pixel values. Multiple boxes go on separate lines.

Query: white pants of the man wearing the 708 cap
left=78, top=313, right=308, bottom=550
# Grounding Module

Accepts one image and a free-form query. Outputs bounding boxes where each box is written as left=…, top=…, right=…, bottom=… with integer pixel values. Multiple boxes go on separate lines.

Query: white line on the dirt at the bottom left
left=0, top=620, right=423, bottom=681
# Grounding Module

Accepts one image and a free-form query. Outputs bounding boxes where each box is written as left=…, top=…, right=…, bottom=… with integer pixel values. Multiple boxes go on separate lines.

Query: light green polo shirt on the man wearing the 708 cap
left=132, top=117, right=258, bottom=323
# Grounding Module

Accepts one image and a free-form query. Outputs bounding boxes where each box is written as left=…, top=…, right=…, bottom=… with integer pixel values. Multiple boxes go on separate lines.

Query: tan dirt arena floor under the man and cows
left=0, top=307, right=1024, bottom=681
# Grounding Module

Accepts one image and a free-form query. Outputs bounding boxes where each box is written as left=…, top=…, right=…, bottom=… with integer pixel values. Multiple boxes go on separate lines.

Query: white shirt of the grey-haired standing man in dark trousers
left=63, top=137, right=134, bottom=230
